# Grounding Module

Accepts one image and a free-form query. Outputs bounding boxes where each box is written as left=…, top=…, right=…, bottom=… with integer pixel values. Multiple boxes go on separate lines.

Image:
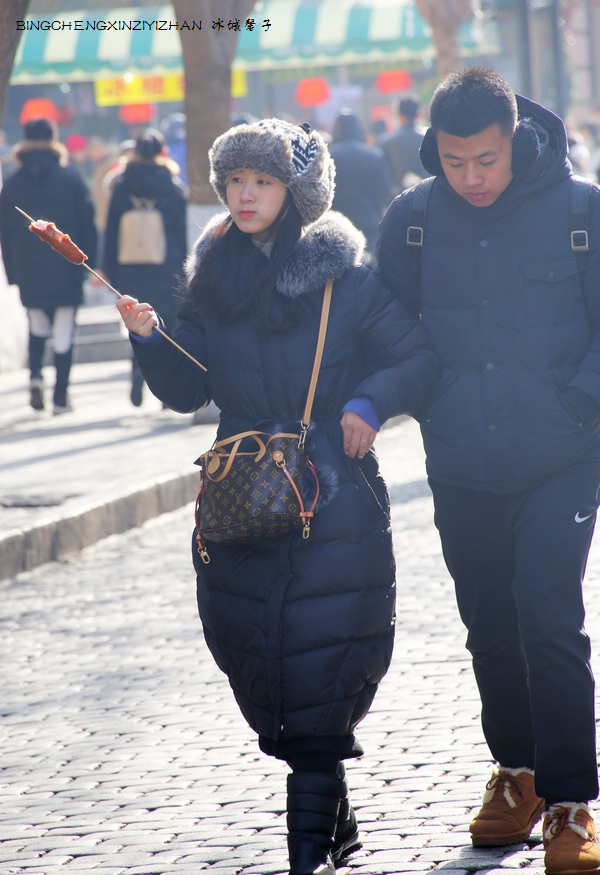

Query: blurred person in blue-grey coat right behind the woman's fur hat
left=329, top=109, right=393, bottom=252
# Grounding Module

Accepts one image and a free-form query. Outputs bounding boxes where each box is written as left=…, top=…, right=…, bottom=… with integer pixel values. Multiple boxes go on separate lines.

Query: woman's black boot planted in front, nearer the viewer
left=287, top=772, right=342, bottom=875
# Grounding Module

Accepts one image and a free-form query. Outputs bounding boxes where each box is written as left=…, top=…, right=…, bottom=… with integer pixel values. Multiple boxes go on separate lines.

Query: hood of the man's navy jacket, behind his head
left=419, top=94, right=571, bottom=185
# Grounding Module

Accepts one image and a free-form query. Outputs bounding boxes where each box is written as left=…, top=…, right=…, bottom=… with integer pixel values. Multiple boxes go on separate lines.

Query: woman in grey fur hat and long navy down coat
left=117, top=119, right=438, bottom=875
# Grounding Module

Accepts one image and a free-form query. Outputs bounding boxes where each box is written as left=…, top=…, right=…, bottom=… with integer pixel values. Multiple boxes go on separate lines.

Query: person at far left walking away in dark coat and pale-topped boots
left=0, top=118, right=97, bottom=414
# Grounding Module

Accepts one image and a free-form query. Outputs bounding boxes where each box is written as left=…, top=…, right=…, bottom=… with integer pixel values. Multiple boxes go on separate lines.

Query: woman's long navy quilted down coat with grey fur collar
left=132, top=212, right=438, bottom=755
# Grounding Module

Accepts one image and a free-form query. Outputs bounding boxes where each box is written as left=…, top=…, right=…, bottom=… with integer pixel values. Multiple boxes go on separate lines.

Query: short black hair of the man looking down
left=429, top=67, right=517, bottom=137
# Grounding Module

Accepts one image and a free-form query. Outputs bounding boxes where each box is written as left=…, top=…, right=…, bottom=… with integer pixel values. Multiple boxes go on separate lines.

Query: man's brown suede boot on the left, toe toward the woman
left=469, top=766, right=544, bottom=847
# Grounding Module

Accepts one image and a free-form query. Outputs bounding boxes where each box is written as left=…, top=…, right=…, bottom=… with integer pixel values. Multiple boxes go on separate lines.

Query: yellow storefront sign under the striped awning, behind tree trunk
left=94, top=70, right=248, bottom=106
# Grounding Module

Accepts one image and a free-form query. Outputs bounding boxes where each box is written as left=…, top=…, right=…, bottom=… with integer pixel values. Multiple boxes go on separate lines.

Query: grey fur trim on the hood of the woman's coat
left=185, top=210, right=365, bottom=298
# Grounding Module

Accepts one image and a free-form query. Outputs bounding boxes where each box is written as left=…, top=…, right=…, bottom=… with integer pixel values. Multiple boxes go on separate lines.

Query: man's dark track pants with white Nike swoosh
left=430, top=462, right=600, bottom=804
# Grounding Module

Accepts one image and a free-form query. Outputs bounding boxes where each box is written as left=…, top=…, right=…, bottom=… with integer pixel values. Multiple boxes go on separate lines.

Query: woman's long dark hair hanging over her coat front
left=190, top=191, right=312, bottom=332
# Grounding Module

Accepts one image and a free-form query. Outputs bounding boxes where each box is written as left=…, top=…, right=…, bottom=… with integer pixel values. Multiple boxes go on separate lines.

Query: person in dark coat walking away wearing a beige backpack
left=102, top=128, right=187, bottom=407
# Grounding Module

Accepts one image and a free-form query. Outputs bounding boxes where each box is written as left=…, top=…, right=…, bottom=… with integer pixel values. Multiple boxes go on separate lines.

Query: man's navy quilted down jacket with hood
left=378, top=97, right=600, bottom=493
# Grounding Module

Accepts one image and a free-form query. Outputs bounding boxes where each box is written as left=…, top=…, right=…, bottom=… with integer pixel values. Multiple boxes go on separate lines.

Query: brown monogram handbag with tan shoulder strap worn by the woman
left=195, top=281, right=333, bottom=563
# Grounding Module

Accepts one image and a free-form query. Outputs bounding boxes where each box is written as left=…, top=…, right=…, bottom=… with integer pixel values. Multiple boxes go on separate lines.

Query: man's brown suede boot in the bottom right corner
left=542, top=802, right=600, bottom=875
